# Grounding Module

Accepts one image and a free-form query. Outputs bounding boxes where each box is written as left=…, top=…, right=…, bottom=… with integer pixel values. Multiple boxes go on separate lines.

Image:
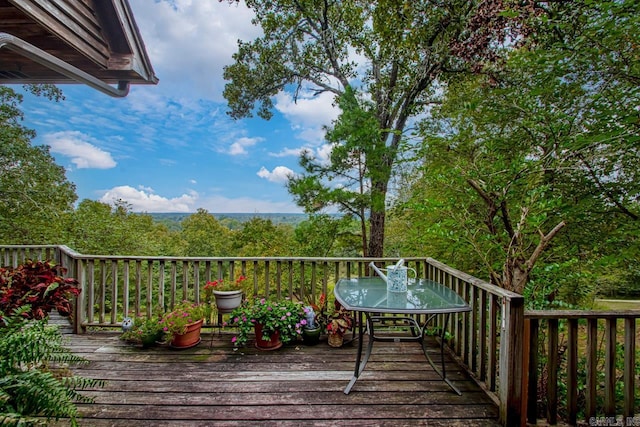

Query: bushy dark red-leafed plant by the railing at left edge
left=0, top=260, right=80, bottom=319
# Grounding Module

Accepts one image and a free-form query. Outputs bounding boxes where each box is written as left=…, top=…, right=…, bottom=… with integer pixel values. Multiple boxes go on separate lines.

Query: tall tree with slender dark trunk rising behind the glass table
left=224, top=0, right=488, bottom=257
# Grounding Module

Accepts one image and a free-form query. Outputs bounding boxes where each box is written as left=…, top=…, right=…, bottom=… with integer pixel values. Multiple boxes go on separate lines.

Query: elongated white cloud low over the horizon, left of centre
left=100, top=185, right=198, bottom=212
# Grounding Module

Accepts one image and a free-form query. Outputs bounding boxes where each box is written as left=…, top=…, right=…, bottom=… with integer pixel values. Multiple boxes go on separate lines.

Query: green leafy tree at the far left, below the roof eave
left=0, top=86, right=77, bottom=244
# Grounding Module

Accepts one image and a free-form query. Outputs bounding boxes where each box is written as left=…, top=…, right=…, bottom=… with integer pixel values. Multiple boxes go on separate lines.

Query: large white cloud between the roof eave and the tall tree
left=131, top=0, right=262, bottom=101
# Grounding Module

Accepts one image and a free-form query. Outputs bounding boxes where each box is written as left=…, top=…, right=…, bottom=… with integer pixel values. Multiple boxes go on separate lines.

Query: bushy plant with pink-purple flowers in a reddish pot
left=225, top=298, right=306, bottom=350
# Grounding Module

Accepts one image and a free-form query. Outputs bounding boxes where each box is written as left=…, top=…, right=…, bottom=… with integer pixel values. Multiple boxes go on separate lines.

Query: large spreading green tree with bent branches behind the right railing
left=392, top=2, right=640, bottom=299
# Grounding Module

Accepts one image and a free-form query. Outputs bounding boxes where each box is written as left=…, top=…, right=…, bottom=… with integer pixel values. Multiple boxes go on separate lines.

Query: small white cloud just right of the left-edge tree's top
left=43, top=131, right=117, bottom=169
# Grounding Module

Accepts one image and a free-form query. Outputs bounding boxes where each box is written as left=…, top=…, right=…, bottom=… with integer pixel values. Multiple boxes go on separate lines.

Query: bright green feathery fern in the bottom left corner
left=0, top=310, right=104, bottom=426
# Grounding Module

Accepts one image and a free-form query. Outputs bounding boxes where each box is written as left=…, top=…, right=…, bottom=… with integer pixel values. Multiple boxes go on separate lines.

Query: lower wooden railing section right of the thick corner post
left=525, top=310, right=640, bottom=426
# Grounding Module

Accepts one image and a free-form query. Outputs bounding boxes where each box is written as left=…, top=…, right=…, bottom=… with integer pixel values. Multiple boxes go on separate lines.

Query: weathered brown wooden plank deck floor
left=58, top=326, right=498, bottom=426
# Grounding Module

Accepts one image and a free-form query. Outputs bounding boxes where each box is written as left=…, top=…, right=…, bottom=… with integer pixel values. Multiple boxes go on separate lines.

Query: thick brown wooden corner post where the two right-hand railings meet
left=499, top=295, right=524, bottom=426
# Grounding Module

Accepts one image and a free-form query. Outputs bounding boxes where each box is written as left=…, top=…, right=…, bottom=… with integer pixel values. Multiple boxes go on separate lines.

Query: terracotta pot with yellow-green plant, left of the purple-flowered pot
left=161, top=301, right=206, bottom=348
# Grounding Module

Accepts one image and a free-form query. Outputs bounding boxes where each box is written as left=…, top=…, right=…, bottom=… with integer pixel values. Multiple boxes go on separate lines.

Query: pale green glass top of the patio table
left=334, top=277, right=471, bottom=313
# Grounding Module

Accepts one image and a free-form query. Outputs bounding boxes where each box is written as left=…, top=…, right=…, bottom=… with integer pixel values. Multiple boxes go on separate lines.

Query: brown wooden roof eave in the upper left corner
left=0, top=0, right=158, bottom=84
